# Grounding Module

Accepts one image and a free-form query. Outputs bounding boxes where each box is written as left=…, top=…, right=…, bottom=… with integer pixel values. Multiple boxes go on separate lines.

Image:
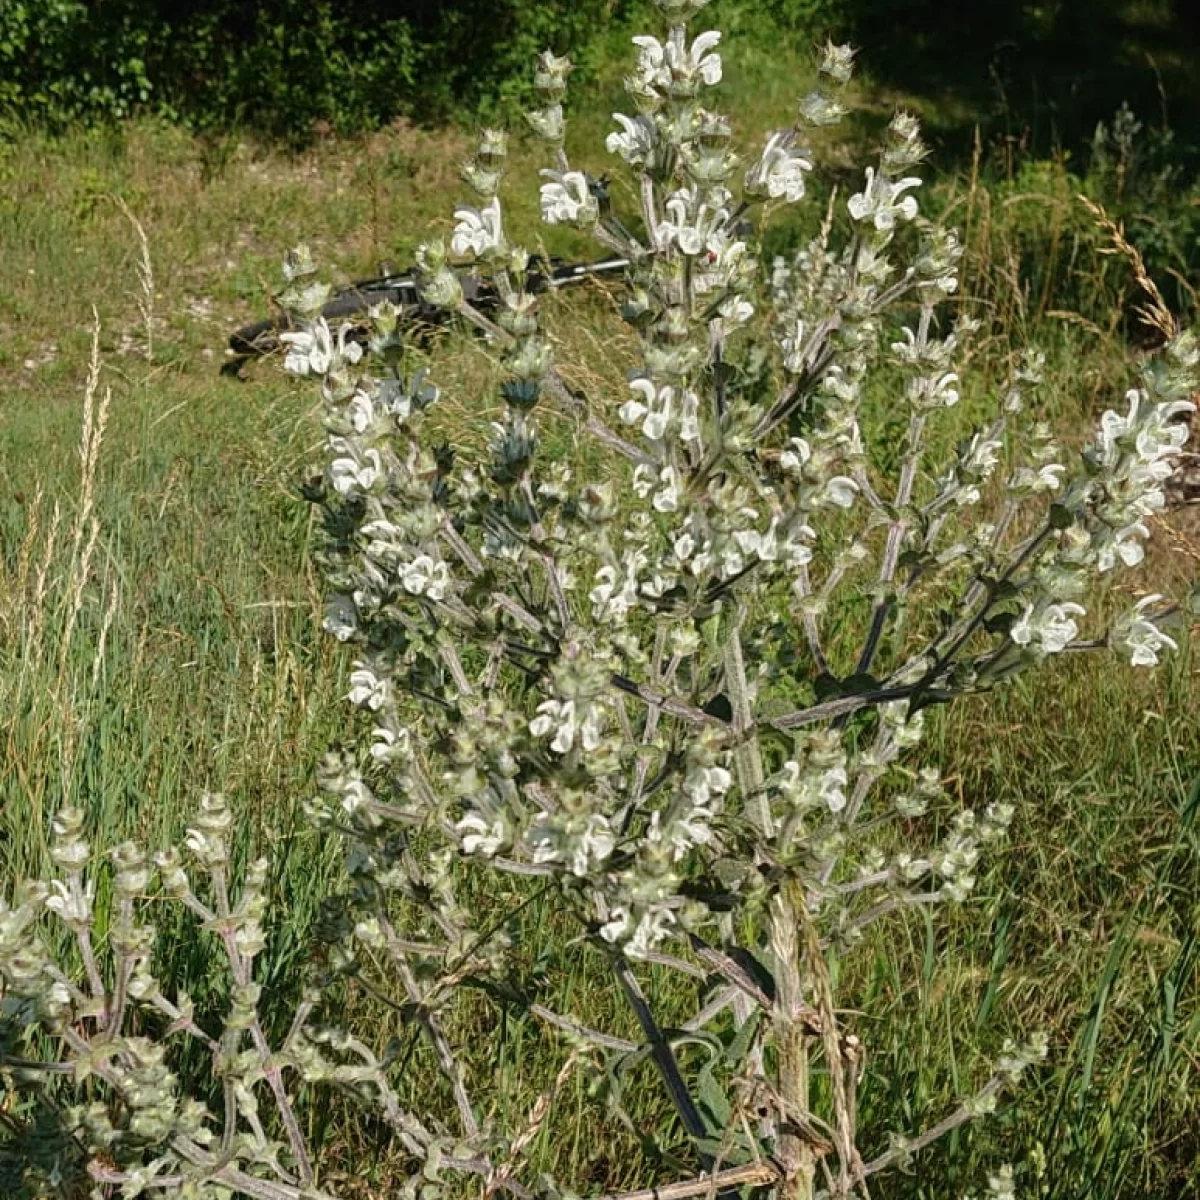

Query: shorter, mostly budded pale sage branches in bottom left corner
left=0, top=794, right=332, bottom=1200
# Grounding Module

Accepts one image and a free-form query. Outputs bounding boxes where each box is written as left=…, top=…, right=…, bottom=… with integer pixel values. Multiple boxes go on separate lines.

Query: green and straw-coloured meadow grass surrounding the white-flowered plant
left=0, top=47, right=1200, bottom=1200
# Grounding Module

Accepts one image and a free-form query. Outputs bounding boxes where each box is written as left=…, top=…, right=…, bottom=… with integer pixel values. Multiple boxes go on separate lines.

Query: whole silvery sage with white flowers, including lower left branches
left=0, top=0, right=1200, bottom=1200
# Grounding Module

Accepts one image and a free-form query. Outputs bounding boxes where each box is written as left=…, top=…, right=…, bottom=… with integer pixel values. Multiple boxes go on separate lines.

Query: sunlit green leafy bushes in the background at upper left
left=0, top=0, right=635, bottom=138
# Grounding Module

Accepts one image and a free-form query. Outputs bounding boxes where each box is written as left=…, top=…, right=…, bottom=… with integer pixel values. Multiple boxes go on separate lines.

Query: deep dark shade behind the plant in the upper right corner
left=801, top=0, right=1200, bottom=160
